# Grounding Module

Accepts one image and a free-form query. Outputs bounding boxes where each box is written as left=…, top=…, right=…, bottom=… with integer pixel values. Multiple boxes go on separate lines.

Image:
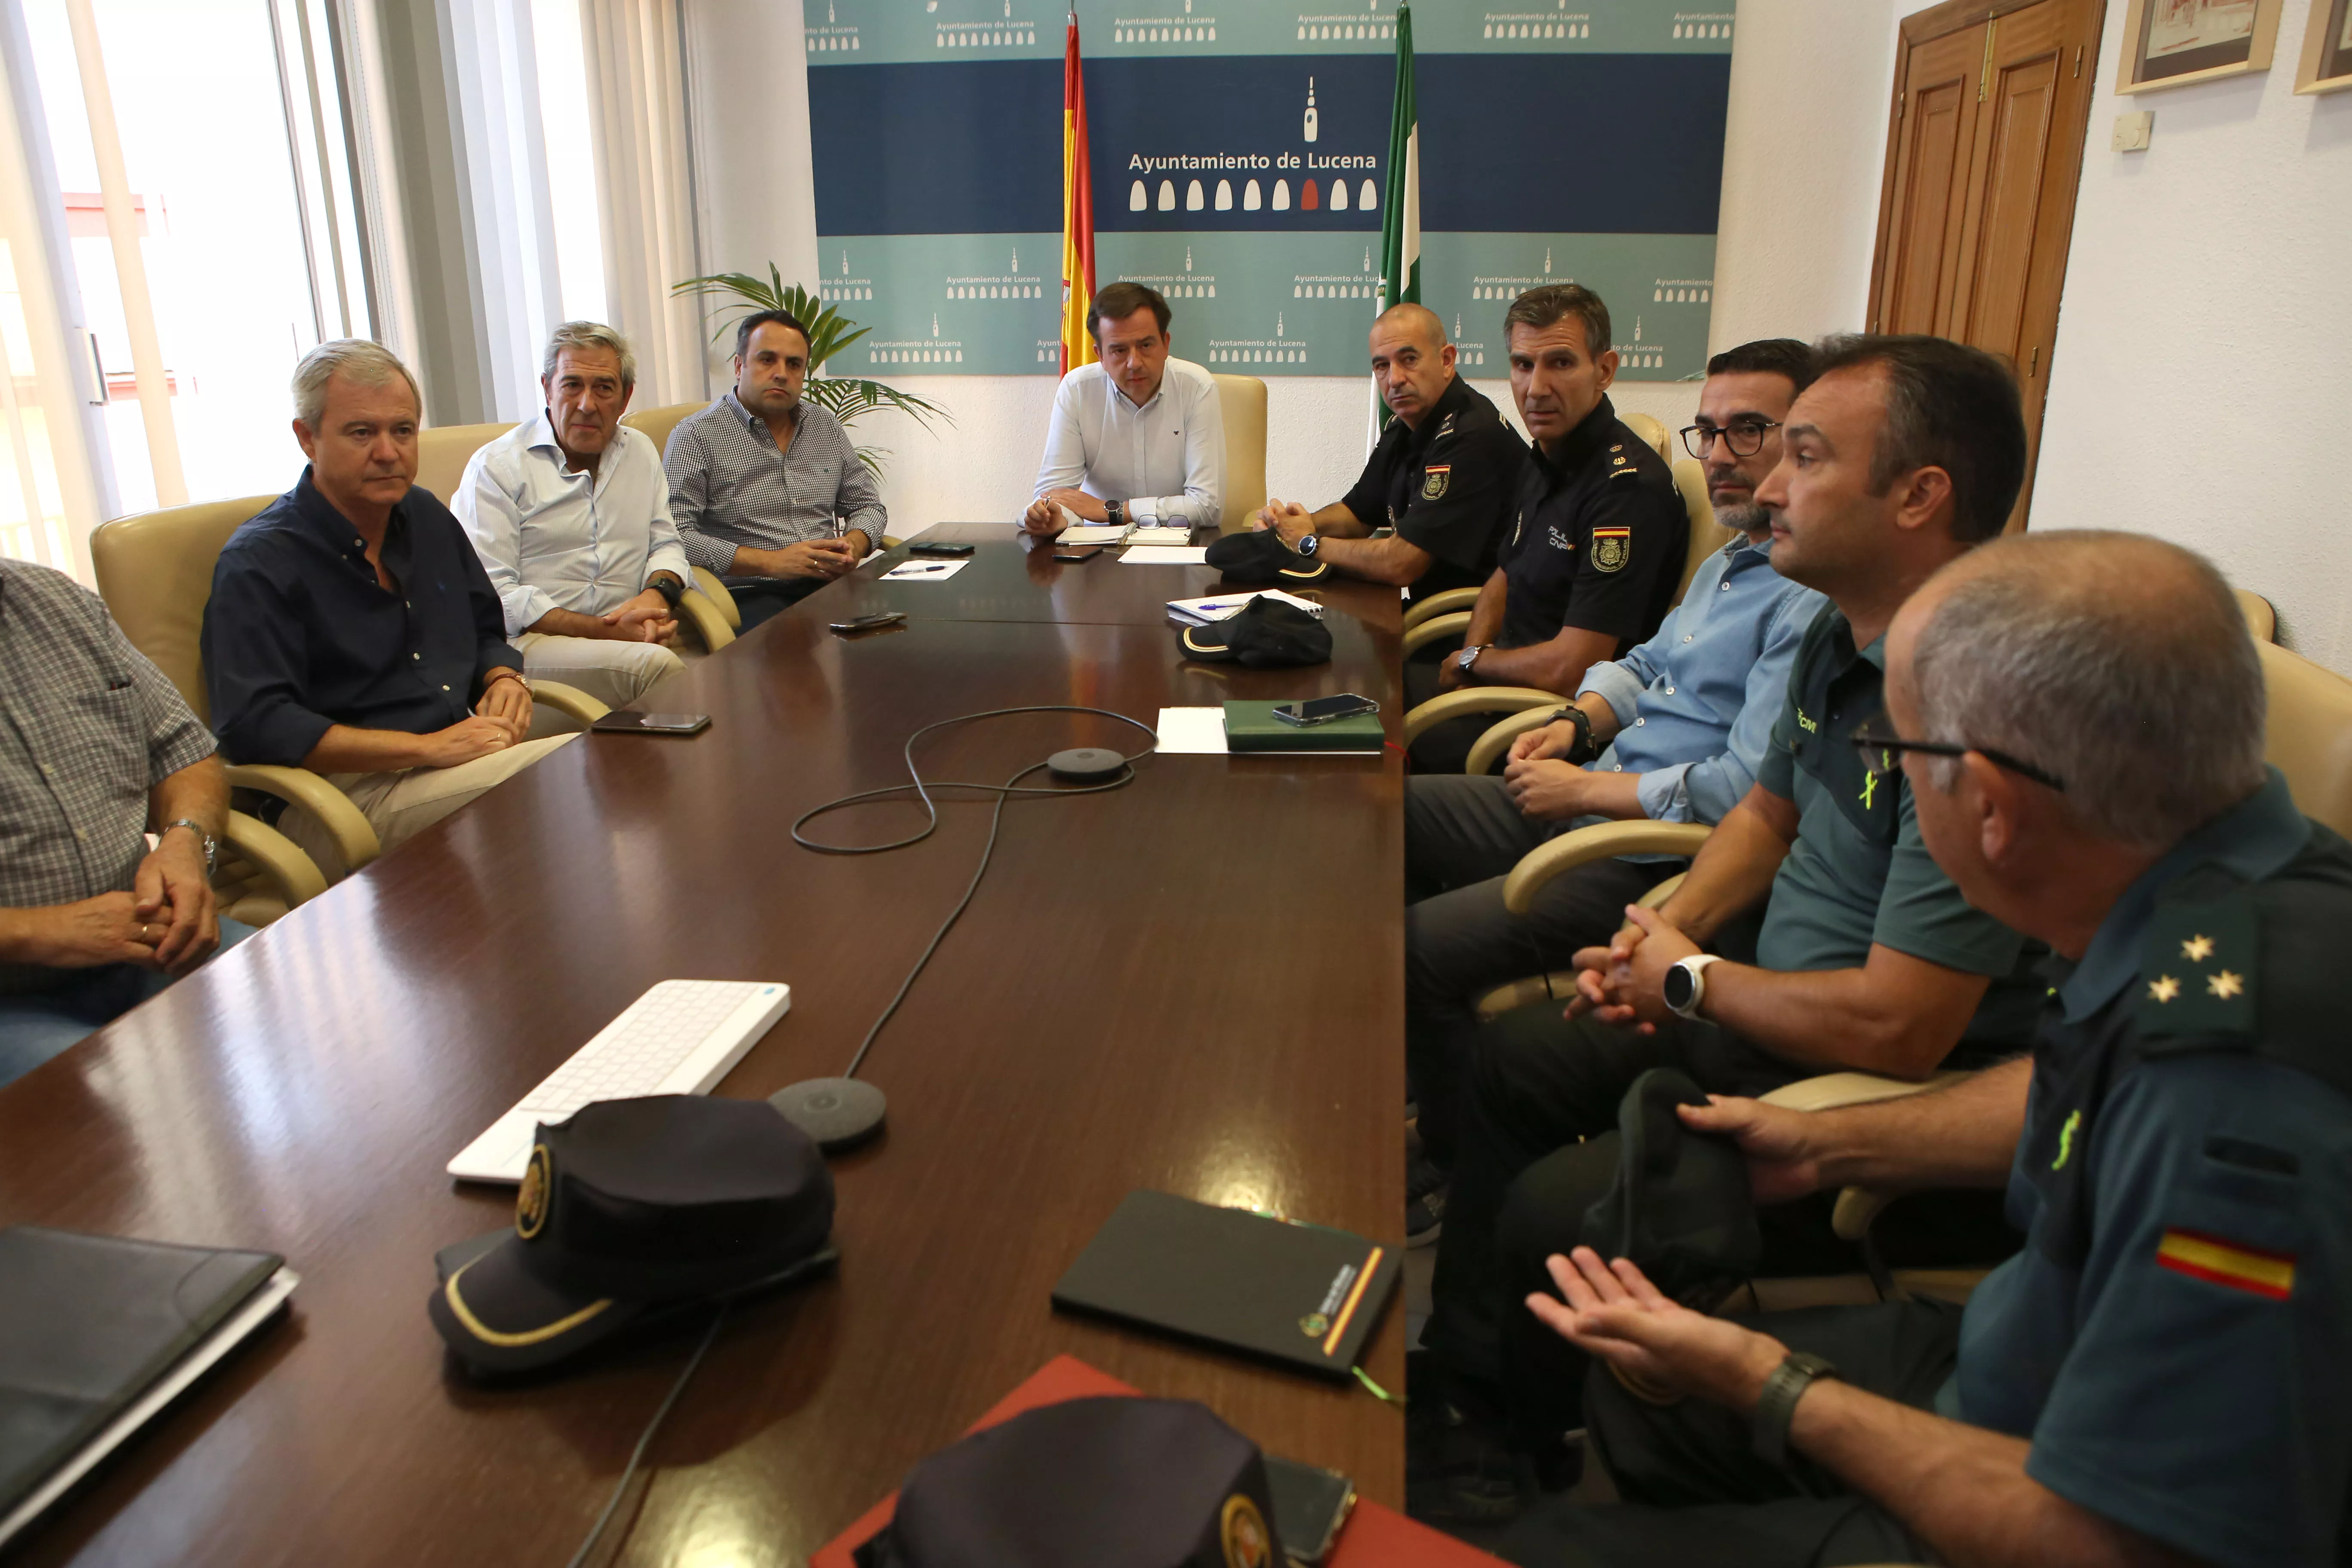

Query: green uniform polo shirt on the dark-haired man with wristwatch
left=1757, top=604, right=2044, bottom=1053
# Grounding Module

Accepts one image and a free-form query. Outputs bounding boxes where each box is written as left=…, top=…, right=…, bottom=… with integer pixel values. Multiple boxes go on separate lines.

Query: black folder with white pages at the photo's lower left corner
left=0, top=1225, right=292, bottom=1540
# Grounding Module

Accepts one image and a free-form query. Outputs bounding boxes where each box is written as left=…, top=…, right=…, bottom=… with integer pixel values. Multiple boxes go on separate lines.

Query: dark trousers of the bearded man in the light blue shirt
left=1404, top=773, right=1684, bottom=1166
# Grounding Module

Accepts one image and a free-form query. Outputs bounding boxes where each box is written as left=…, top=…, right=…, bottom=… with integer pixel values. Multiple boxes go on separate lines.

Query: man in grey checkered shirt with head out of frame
left=0, top=560, right=252, bottom=1084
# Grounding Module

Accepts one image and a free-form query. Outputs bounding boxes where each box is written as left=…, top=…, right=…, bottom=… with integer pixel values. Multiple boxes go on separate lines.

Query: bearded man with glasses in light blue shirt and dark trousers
left=1400, top=338, right=1823, bottom=1246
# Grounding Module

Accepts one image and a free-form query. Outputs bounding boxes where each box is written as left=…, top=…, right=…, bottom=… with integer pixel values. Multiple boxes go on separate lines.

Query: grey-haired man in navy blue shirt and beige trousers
left=202, top=339, right=572, bottom=877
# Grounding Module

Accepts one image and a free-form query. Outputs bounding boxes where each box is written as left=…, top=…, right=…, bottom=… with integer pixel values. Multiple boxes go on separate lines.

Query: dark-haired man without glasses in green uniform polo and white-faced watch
left=1406, top=336, right=2044, bottom=1521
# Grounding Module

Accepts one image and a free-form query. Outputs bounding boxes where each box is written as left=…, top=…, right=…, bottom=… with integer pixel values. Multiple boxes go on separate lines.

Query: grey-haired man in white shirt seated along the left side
left=449, top=322, right=689, bottom=707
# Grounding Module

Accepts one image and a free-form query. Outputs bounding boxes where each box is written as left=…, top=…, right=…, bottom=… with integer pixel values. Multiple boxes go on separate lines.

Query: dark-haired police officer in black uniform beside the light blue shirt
left=1406, top=282, right=1691, bottom=773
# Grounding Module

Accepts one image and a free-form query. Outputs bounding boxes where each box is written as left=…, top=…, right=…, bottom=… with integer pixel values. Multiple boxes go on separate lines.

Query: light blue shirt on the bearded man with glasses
left=1578, top=534, right=1828, bottom=825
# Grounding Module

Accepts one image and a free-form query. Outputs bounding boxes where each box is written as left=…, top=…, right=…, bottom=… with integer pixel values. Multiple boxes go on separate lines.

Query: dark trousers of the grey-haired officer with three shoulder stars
left=1496, top=1300, right=1959, bottom=1568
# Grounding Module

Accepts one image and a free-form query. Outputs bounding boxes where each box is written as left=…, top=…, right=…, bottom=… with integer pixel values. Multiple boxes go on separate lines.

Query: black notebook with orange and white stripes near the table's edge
left=1054, top=1192, right=1400, bottom=1378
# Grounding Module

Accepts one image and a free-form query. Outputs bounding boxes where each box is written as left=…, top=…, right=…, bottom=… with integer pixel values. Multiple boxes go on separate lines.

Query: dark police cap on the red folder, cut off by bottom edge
left=856, top=1399, right=1284, bottom=1568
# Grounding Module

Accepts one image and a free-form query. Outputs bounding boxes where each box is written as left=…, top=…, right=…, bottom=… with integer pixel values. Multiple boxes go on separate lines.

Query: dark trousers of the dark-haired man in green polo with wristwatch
left=1421, top=1004, right=1860, bottom=1441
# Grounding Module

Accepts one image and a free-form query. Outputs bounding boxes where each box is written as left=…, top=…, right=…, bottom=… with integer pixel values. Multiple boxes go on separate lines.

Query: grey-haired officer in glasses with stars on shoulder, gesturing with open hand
left=1503, top=531, right=2352, bottom=1566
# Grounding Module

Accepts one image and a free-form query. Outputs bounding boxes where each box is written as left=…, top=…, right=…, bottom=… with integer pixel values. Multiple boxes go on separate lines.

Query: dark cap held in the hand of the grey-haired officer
left=1583, top=1067, right=1764, bottom=1300
